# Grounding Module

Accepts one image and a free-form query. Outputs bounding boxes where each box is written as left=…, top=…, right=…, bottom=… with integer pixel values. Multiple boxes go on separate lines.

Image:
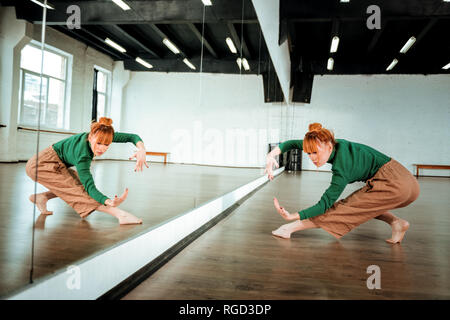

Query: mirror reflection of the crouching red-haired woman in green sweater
left=26, top=118, right=148, bottom=224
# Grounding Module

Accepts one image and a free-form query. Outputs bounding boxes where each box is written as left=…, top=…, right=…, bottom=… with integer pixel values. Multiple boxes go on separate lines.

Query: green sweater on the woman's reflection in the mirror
left=53, top=132, right=142, bottom=204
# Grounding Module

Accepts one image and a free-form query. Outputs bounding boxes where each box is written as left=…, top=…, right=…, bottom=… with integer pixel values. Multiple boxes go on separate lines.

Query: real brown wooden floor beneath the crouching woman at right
left=124, top=172, right=450, bottom=300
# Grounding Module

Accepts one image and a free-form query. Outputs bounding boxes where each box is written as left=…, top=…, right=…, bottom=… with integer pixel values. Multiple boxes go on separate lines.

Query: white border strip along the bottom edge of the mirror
left=8, top=167, right=284, bottom=300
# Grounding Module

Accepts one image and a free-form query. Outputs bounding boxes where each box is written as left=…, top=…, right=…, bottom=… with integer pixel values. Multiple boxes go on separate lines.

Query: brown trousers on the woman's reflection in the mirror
left=26, top=147, right=101, bottom=218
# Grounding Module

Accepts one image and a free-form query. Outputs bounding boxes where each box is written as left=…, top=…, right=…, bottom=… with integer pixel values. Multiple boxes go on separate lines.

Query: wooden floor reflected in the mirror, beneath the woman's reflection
left=0, top=161, right=262, bottom=296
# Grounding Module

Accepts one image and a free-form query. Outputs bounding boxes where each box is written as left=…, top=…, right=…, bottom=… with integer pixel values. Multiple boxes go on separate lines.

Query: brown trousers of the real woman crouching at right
left=310, top=159, right=420, bottom=239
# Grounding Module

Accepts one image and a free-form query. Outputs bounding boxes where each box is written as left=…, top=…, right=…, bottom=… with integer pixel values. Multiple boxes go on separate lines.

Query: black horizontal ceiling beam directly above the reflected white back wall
left=124, top=57, right=266, bottom=75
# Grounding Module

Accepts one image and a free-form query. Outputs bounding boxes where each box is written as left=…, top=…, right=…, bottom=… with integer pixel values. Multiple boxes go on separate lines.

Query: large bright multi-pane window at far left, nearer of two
left=19, top=42, right=70, bottom=129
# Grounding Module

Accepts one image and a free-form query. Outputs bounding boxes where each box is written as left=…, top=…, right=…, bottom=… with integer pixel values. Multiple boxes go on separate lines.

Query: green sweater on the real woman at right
left=279, top=139, right=391, bottom=220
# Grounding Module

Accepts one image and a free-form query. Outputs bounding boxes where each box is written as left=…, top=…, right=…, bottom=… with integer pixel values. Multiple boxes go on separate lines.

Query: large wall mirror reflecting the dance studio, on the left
left=0, top=0, right=287, bottom=296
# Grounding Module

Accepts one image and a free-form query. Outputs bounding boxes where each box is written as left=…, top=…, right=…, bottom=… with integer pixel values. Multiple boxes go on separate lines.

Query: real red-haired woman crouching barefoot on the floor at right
left=265, top=123, right=420, bottom=244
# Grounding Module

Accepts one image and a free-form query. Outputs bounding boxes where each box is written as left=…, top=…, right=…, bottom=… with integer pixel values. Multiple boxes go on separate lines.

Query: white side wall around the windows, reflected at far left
left=0, top=7, right=113, bottom=161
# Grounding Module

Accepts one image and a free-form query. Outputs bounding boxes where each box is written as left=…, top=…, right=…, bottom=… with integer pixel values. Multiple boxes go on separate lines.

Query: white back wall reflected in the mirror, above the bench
left=116, top=72, right=281, bottom=167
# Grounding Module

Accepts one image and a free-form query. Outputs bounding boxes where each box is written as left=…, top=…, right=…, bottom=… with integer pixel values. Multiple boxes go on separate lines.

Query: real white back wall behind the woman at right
left=286, top=75, right=450, bottom=176
